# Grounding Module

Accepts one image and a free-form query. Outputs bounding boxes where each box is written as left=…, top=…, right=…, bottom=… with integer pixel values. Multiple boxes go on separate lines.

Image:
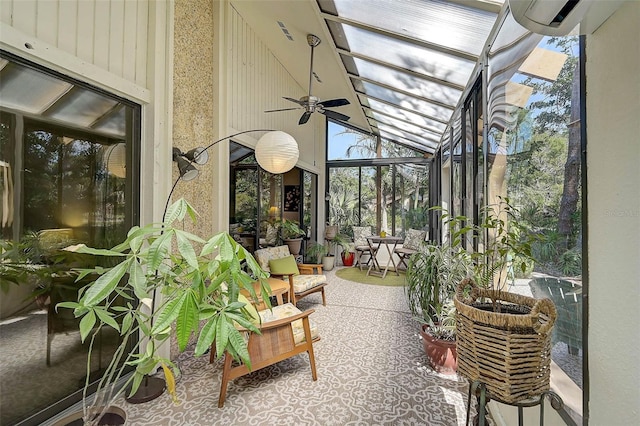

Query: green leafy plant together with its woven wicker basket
left=450, top=199, right=556, bottom=404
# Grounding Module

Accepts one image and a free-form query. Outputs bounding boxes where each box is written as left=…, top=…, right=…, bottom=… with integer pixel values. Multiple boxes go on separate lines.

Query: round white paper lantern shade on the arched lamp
left=256, top=130, right=300, bottom=174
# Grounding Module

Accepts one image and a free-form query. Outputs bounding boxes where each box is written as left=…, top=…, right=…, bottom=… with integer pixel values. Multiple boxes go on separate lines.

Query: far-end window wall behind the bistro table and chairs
left=327, top=122, right=429, bottom=237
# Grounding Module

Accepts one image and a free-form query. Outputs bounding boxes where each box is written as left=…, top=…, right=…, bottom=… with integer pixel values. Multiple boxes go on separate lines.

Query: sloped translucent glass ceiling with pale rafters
left=317, top=0, right=503, bottom=154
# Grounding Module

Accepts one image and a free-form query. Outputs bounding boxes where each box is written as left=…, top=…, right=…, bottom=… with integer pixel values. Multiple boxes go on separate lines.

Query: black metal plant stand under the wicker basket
left=464, top=380, right=564, bottom=426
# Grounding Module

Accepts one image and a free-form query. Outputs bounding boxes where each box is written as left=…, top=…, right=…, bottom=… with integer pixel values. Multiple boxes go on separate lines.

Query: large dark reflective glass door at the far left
left=0, top=54, right=140, bottom=424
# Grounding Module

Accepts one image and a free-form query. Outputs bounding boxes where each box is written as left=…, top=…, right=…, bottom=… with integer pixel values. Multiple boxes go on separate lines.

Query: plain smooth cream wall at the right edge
left=586, top=1, right=640, bottom=426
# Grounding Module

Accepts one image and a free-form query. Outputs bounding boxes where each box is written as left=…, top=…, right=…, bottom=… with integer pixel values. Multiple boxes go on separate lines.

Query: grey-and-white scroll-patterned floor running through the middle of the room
left=117, top=271, right=475, bottom=426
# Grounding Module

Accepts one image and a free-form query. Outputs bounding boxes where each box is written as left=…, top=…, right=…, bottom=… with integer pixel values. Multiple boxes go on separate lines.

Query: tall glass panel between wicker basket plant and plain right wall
left=487, top=16, right=586, bottom=424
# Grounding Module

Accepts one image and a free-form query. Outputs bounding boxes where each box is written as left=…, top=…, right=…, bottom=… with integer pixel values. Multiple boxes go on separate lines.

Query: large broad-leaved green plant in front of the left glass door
left=56, top=200, right=269, bottom=425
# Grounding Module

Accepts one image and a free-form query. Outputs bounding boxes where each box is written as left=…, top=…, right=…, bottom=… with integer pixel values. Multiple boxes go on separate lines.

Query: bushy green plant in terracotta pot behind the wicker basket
left=405, top=239, right=472, bottom=373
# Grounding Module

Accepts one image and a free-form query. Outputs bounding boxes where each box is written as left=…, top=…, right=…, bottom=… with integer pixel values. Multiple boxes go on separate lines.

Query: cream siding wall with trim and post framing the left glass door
left=0, top=0, right=173, bottom=223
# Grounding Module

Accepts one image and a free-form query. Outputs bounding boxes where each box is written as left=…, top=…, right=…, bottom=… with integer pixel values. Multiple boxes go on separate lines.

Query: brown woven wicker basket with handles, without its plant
left=454, top=279, right=556, bottom=404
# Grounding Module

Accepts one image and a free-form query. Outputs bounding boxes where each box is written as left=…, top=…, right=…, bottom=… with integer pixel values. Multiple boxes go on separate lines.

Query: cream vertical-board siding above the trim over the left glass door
left=0, top=0, right=149, bottom=87
